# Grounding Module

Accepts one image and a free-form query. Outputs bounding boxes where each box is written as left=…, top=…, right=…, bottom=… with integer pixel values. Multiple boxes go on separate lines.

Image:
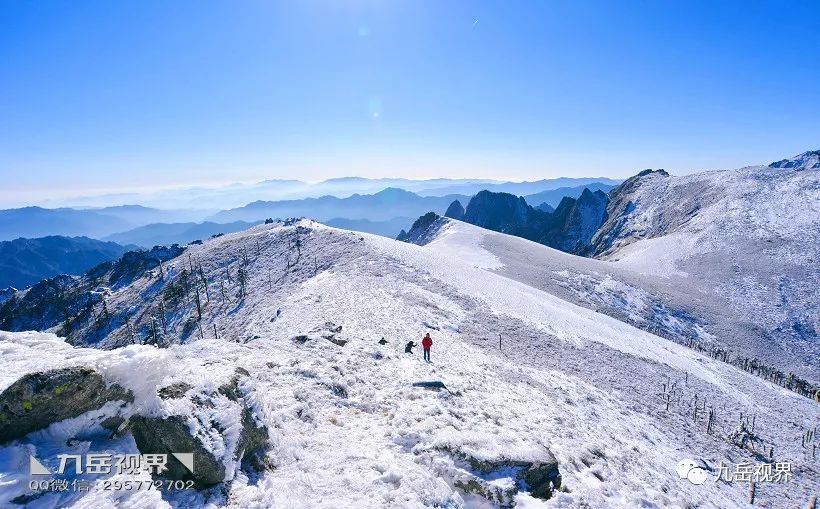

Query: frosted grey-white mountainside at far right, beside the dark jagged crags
left=592, top=161, right=820, bottom=381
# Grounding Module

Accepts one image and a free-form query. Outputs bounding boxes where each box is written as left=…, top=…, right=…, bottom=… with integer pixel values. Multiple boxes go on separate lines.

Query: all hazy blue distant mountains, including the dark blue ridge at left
left=0, top=178, right=612, bottom=288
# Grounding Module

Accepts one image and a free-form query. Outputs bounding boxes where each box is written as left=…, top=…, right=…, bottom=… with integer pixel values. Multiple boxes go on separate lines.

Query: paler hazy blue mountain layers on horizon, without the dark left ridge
left=0, top=178, right=612, bottom=247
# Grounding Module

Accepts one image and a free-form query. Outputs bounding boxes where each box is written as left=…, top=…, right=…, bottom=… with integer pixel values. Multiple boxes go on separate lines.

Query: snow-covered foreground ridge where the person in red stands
left=0, top=221, right=820, bottom=508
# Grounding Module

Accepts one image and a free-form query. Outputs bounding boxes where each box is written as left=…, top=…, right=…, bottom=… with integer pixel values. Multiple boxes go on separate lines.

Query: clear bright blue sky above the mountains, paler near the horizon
left=0, top=0, right=820, bottom=204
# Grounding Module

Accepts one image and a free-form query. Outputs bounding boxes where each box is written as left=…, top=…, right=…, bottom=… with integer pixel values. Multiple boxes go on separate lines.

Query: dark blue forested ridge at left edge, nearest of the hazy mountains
left=0, top=236, right=135, bottom=288
